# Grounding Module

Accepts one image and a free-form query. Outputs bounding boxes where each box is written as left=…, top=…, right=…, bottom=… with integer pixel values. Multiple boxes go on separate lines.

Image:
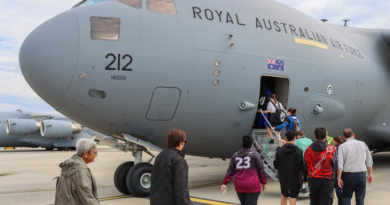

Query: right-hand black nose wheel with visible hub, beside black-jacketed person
left=126, top=163, right=153, bottom=197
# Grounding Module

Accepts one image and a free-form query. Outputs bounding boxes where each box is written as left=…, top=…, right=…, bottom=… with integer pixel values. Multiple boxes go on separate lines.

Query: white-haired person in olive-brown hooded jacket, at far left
left=55, top=138, right=99, bottom=205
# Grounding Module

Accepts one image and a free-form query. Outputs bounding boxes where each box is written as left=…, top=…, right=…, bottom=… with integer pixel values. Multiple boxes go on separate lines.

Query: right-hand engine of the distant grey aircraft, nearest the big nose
left=41, top=120, right=81, bottom=138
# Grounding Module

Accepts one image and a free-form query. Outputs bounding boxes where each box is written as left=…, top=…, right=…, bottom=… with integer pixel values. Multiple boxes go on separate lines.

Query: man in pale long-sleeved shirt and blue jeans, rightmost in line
left=337, top=128, right=373, bottom=205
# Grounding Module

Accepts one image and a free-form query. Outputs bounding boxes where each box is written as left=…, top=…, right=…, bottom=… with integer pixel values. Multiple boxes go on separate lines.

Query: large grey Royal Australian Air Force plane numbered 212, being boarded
left=20, top=0, right=390, bottom=196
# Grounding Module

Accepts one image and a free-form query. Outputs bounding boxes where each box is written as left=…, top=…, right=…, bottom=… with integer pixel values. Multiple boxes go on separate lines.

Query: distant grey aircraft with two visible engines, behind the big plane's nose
left=0, top=110, right=97, bottom=151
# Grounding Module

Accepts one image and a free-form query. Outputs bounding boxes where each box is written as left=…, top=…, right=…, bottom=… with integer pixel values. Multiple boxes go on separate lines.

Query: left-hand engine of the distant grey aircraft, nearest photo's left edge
left=6, top=118, right=41, bottom=135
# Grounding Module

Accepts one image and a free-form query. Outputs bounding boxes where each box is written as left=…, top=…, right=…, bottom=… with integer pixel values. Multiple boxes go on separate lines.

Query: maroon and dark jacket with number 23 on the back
left=222, top=148, right=267, bottom=193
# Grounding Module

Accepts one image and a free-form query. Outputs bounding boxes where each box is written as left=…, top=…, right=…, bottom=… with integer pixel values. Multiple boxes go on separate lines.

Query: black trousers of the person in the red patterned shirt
left=308, top=178, right=334, bottom=205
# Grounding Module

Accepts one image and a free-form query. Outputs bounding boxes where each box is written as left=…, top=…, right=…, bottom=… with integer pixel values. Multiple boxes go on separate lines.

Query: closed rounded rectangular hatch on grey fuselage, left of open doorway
left=146, top=87, right=181, bottom=121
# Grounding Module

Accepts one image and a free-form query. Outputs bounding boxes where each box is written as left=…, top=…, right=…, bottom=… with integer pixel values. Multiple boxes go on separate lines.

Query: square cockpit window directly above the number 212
left=90, top=17, right=121, bottom=41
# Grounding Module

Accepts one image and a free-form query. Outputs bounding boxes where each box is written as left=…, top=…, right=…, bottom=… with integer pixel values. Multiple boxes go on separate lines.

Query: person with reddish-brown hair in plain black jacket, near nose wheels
left=150, top=129, right=192, bottom=205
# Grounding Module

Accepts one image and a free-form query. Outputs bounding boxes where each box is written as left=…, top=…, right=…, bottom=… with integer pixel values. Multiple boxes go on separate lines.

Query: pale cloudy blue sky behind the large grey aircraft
left=0, top=0, right=390, bottom=113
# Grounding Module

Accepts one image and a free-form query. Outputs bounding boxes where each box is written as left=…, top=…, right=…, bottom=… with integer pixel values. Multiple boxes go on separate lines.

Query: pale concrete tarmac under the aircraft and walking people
left=0, top=145, right=390, bottom=205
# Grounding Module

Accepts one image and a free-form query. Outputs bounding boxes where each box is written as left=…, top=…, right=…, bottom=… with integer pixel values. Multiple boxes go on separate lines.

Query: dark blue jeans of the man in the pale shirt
left=341, top=172, right=367, bottom=205
